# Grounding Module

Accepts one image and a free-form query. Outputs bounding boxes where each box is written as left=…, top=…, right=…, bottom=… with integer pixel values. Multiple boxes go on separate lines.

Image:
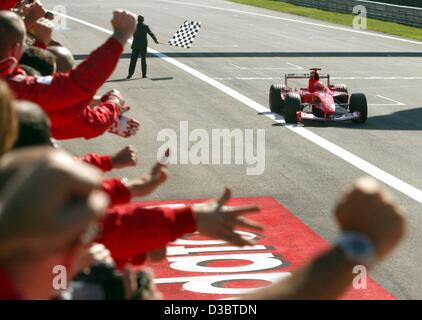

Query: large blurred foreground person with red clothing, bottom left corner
left=0, top=147, right=107, bottom=299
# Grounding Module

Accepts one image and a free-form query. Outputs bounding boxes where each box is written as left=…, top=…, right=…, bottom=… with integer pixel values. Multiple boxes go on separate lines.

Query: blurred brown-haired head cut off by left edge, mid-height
left=0, top=79, right=18, bottom=157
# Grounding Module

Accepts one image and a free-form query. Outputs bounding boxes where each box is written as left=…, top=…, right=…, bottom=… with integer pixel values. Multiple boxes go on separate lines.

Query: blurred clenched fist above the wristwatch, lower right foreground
left=335, top=177, right=405, bottom=259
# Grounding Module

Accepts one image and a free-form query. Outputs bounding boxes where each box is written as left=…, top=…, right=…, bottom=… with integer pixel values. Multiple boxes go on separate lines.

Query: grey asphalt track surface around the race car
left=43, top=0, right=422, bottom=299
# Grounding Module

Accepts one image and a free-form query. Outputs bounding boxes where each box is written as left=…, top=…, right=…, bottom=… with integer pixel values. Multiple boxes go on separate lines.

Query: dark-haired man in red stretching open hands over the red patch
left=9, top=102, right=260, bottom=267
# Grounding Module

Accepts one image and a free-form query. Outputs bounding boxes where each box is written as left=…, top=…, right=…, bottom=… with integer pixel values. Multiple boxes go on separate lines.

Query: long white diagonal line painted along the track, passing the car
left=56, top=13, right=422, bottom=203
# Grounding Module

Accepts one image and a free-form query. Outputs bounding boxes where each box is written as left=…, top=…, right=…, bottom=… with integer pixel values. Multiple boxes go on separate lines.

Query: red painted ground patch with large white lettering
left=145, top=197, right=394, bottom=300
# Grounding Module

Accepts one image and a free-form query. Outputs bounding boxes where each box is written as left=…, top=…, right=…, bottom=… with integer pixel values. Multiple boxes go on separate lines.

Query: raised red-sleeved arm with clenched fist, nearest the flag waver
left=8, top=11, right=136, bottom=112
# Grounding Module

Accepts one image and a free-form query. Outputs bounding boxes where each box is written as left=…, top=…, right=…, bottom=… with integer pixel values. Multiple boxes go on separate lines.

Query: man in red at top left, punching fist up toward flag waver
left=0, top=11, right=139, bottom=138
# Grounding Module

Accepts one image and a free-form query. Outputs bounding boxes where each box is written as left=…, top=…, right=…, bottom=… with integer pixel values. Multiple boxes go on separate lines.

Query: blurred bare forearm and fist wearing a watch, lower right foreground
left=247, top=178, right=405, bottom=300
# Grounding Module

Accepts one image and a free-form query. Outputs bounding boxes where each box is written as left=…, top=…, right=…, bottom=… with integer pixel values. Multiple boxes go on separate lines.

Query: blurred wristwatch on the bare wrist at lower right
left=337, top=232, right=376, bottom=267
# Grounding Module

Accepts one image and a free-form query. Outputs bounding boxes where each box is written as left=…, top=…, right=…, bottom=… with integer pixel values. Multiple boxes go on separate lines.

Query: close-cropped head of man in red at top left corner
left=0, top=10, right=26, bottom=61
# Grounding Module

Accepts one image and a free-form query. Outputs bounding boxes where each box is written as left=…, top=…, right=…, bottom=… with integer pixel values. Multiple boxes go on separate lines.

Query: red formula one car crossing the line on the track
left=270, top=68, right=368, bottom=123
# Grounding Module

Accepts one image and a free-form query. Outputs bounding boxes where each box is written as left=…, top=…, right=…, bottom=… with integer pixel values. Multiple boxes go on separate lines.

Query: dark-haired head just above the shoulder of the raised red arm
left=20, top=47, right=56, bottom=76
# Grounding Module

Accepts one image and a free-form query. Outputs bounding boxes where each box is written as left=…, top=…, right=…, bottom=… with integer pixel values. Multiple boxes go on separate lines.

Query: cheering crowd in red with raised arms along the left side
left=0, top=1, right=405, bottom=299
